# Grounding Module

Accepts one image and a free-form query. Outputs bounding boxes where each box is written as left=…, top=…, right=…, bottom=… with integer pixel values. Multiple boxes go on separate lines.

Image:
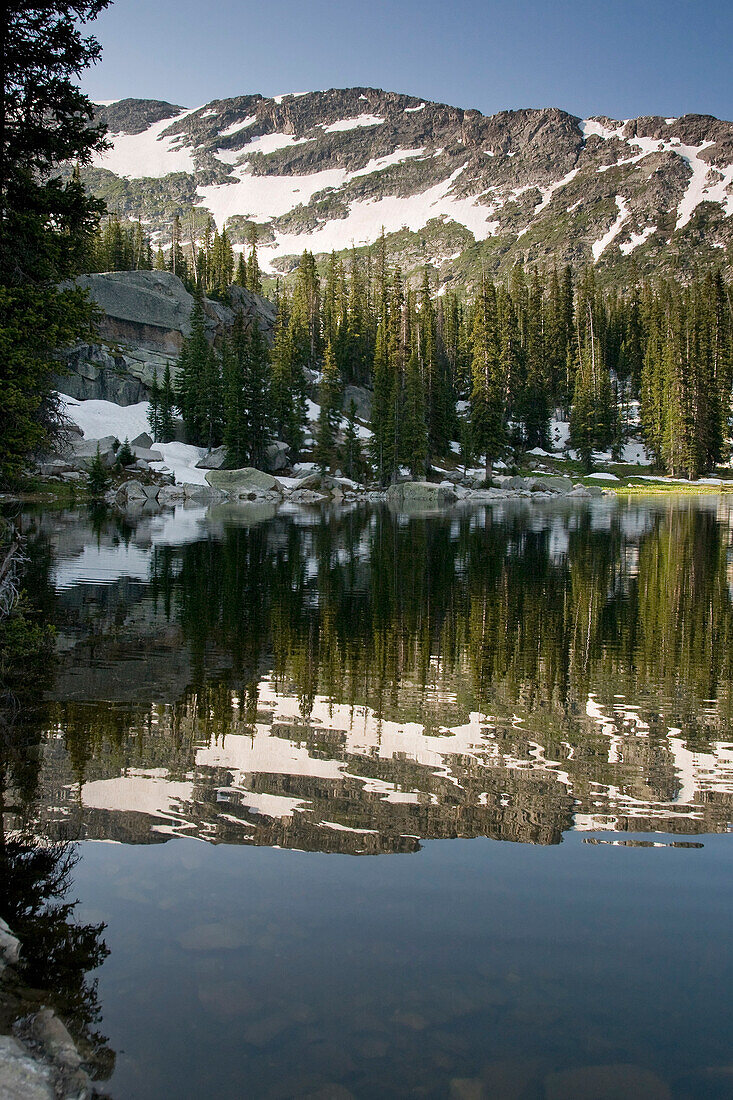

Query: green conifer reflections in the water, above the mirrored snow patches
left=144, top=503, right=732, bottom=734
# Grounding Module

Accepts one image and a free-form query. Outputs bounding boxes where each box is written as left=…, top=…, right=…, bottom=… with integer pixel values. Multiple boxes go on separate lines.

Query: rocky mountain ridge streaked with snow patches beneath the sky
left=85, top=88, right=733, bottom=288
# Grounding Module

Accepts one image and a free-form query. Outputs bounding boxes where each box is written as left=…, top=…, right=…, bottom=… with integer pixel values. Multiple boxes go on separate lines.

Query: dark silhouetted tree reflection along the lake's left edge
left=0, top=528, right=114, bottom=1079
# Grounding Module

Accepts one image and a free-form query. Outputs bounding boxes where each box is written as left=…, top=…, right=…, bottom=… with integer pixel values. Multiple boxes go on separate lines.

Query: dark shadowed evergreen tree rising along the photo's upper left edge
left=0, top=0, right=107, bottom=485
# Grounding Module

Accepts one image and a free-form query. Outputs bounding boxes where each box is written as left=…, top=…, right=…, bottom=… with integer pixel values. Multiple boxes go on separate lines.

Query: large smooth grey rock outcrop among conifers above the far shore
left=55, top=272, right=275, bottom=405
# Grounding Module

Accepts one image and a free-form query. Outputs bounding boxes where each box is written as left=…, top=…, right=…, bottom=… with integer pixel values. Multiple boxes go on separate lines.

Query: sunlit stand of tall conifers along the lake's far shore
left=95, top=219, right=733, bottom=484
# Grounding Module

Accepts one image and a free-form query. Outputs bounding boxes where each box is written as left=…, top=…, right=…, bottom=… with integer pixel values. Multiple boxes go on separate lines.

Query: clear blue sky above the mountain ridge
left=84, top=0, right=733, bottom=119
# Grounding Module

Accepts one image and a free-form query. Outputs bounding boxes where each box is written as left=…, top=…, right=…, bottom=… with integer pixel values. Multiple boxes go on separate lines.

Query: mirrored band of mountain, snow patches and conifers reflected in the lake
left=14, top=498, right=733, bottom=853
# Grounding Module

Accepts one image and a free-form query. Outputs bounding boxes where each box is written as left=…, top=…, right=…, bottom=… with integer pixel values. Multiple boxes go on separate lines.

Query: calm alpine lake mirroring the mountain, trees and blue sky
left=4, top=494, right=733, bottom=1100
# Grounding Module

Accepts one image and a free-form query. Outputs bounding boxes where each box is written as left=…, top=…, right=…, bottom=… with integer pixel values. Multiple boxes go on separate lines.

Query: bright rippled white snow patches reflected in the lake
left=65, top=679, right=733, bottom=838
